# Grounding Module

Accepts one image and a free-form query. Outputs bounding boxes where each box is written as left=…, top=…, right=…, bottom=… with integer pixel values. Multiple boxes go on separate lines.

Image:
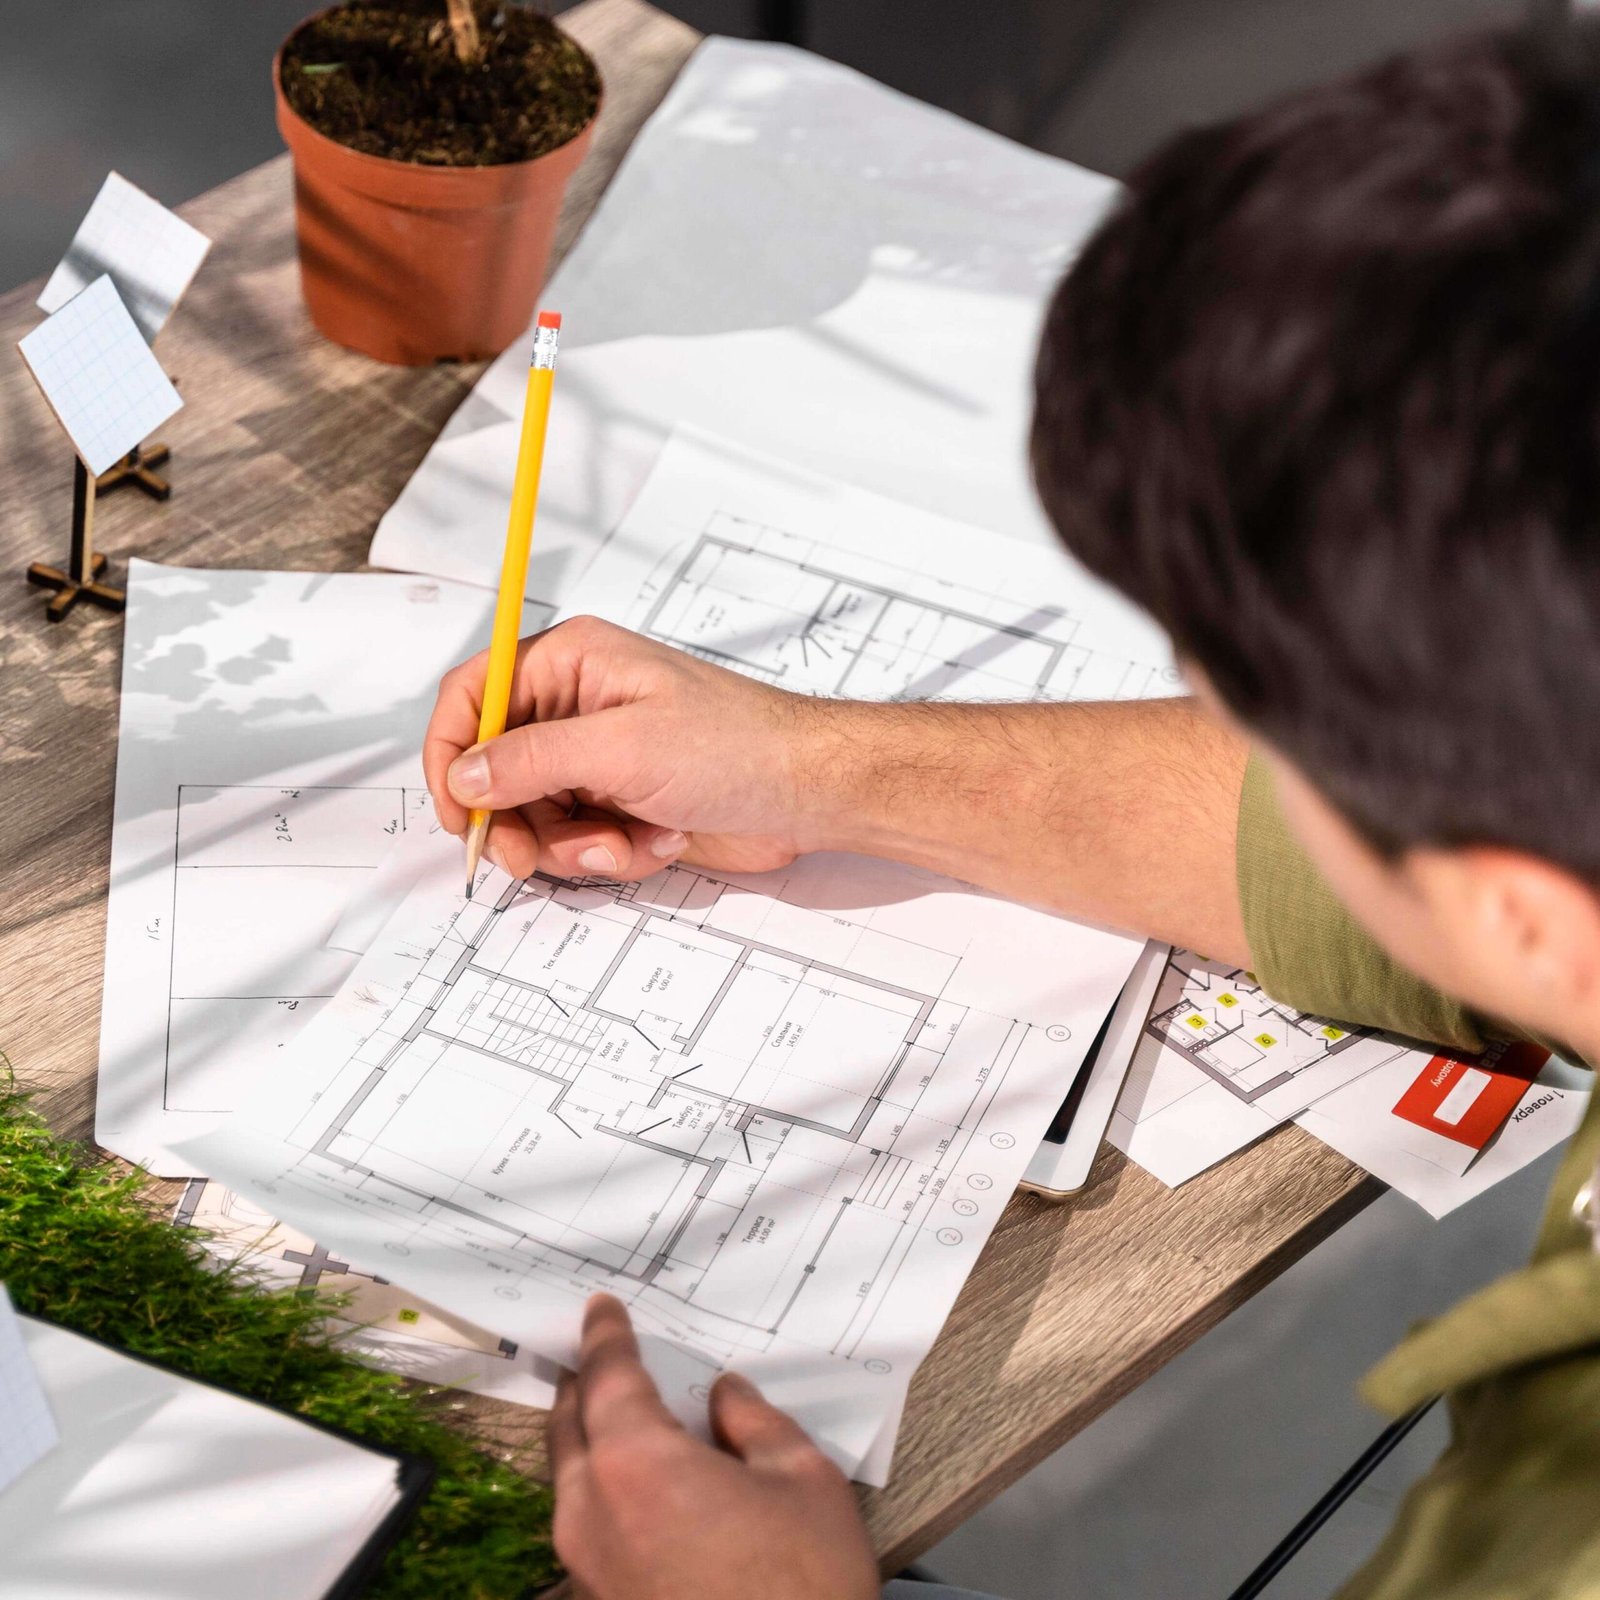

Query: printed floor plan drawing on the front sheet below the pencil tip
left=291, top=869, right=1029, bottom=1355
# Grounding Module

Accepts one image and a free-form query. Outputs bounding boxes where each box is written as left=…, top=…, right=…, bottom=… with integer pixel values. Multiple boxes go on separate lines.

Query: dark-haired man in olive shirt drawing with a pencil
left=426, top=15, right=1600, bottom=1600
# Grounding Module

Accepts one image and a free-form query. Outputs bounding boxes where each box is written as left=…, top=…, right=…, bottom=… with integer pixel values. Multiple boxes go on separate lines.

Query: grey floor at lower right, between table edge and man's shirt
left=926, top=1155, right=1555, bottom=1600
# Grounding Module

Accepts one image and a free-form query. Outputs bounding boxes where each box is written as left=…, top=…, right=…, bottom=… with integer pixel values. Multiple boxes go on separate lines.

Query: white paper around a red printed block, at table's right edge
left=1294, top=1051, right=1594, bottom=1218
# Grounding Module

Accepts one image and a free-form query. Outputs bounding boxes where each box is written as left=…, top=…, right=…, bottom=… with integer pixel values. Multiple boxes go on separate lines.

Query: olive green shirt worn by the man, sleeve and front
left=1238, top=758, right=1600, bottom=1600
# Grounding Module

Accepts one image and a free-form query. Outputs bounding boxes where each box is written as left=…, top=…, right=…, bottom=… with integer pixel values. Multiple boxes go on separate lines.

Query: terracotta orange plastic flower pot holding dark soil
left=272, top=22, right=598, bottom=366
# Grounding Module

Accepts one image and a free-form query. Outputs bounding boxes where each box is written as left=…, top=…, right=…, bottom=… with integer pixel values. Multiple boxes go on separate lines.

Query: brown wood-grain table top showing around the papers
left=0, top=0, right=1379, bottom=1571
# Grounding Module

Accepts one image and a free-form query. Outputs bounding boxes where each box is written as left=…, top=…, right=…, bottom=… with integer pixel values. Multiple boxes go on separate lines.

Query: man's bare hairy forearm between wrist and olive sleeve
left=806, top=699, right=1250, bottom=965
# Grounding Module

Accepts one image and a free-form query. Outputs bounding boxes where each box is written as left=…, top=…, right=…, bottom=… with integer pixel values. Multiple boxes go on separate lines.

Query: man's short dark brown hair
left=1032, top=27, right=1600, bottom=877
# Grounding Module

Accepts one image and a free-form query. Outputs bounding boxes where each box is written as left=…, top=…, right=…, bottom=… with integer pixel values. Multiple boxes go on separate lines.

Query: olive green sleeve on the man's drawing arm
left=1238, top=754, right=1502, bottom=1051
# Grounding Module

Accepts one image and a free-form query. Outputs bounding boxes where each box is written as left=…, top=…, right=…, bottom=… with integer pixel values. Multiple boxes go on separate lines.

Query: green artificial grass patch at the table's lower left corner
left=0, top=1061, right=558, bottom=1600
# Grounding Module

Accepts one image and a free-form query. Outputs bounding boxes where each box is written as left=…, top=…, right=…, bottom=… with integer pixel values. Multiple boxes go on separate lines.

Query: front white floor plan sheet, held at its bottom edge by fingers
left=184, top=834, right=1138, bottom=1470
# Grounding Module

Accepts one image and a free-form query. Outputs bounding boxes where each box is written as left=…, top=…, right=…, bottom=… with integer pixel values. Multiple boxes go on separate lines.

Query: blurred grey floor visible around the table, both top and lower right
left=0, top=0, right=1549, bottom=1600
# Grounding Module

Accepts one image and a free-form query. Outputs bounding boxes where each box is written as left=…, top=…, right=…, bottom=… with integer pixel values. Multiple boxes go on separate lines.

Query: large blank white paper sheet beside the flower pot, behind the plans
left=371, top=38, right=1117, bottom=605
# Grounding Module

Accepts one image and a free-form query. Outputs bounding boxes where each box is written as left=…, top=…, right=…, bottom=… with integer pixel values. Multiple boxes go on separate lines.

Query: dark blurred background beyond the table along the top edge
left=0, top=0, right=1517, bottom=290
